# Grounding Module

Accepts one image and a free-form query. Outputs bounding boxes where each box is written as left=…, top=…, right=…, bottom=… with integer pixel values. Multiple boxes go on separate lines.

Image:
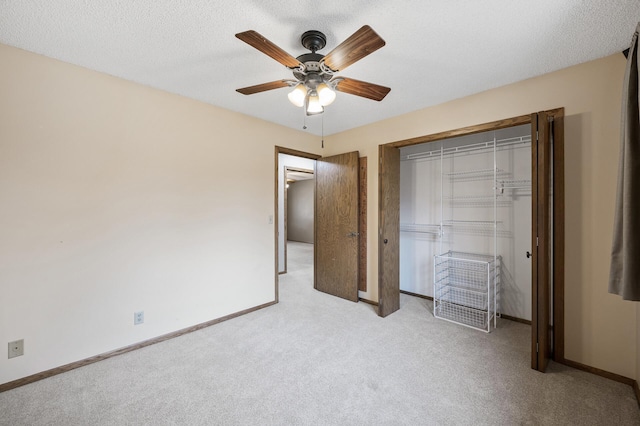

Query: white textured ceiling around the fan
left=0, top=0, right=640, bottom=135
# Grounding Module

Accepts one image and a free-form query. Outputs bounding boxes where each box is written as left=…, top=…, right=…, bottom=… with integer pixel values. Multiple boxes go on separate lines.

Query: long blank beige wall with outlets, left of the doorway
left=0, top=45, right=318, bottom=383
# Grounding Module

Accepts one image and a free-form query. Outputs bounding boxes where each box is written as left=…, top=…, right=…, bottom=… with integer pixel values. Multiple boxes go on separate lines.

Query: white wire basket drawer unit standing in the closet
left=433, top=251, right=501, bottom=333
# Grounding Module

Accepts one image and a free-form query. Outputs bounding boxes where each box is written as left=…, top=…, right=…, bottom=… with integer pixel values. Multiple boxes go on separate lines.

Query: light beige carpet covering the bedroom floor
left=0, top=243, right=640, bottom=425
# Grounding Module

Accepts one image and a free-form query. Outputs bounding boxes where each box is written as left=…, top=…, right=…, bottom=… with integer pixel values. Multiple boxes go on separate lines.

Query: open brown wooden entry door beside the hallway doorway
left=314, top=151, right=359, bottom=302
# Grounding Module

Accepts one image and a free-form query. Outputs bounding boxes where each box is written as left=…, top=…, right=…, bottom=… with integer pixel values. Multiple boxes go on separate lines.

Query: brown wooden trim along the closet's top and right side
left=378, top=108, right=565, bottom=363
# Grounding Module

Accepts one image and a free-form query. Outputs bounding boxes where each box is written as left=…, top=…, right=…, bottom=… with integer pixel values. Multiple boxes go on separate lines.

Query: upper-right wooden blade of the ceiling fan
left=324, top=25, right=385, bottom=71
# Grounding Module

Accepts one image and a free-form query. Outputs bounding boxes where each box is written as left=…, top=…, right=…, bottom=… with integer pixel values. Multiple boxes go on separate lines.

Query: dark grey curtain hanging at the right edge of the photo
left=609, top=23, right=640, bottom=301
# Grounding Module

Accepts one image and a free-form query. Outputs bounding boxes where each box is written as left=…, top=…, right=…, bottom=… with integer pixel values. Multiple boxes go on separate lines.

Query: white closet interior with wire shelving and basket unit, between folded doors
left=400, top=124, right=532, bottom=332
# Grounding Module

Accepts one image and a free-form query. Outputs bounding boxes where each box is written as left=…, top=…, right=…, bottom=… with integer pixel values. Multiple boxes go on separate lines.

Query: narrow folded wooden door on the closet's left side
left=378, top=145, right=400, bottom=317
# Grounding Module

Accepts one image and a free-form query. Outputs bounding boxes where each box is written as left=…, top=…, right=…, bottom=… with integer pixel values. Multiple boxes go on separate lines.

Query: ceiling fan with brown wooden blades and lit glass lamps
left=236, top=25, right=391, bottom=115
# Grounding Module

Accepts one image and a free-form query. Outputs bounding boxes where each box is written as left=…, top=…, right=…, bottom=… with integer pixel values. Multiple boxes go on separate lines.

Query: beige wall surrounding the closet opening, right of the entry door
left=325, top=54, right=640, bottom=378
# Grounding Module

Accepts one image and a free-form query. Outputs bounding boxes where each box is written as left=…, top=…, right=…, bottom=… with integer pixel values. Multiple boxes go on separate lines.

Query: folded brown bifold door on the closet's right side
left=531, top=112, right=553, bottom=372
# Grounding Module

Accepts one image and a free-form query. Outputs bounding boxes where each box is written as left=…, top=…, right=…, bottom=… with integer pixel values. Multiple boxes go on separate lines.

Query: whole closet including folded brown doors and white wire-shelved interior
left=378, top=108, right=564, bottom=371
